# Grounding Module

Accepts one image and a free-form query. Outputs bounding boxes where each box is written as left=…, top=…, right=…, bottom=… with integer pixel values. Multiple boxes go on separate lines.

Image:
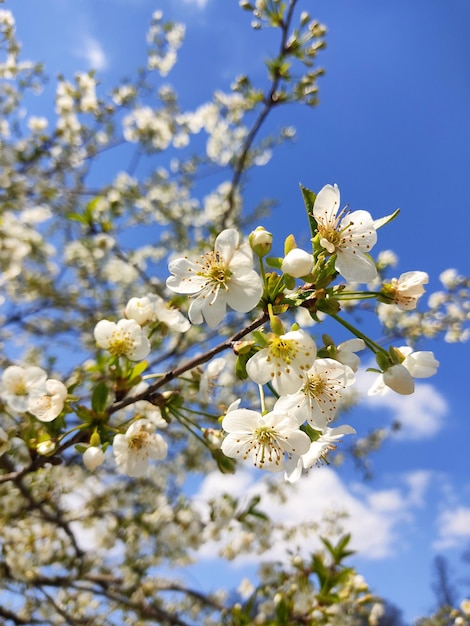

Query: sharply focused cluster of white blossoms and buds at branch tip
left=162, top=185, right=438, bottom=482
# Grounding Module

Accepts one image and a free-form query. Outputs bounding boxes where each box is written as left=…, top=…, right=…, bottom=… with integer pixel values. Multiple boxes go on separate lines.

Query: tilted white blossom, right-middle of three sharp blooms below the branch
left=274, top=359, right=356, bottom=430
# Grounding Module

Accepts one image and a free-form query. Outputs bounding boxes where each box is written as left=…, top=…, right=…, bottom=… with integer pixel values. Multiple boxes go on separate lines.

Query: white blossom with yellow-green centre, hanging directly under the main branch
left=246, top=330, right=317, bottom=395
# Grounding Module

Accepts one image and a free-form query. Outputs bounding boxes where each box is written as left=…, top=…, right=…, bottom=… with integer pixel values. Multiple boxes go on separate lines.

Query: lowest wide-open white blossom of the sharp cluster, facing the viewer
left=222, top=409, right=310, bottom=472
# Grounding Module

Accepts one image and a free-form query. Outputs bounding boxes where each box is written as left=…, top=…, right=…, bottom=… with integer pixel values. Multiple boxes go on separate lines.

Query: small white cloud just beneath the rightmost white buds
left=358, top=372, right=448, bottom=440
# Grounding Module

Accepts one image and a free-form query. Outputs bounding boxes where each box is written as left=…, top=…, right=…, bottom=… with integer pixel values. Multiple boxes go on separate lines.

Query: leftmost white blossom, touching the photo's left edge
left=0, top=365, right=47, bottom=413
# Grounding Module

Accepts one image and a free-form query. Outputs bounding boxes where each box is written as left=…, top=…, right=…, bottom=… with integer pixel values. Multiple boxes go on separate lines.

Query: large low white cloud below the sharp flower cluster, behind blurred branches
left=195, top=467, right=430, bottom=565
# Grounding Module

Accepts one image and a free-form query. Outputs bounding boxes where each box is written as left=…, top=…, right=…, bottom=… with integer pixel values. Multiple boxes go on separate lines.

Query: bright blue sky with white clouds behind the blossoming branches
left=4, top=0, right=470, bottom=619
